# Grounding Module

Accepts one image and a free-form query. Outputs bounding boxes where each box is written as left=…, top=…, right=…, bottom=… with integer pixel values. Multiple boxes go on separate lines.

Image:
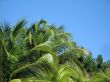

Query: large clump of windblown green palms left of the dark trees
left=0, top=19, right=85, bottom=82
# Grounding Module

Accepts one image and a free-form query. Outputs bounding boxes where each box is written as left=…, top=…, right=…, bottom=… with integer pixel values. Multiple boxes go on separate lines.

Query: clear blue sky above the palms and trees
left=0, top=0, right=110, bottom=60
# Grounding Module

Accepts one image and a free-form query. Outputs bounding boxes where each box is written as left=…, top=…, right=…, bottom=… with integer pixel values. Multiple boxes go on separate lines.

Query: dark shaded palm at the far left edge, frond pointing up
left=0, top=20, right=25, bottom=82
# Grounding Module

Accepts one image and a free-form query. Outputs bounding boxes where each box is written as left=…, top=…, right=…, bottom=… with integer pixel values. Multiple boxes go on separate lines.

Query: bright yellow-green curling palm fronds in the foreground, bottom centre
left=11, top=54, right=85, bottom=82
